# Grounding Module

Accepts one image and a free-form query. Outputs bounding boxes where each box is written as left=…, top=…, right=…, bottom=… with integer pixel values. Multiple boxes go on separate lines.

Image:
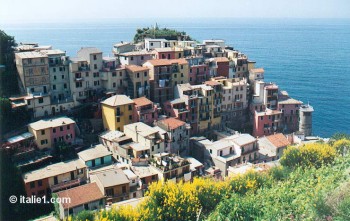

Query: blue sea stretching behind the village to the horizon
left=0, top=18, right=350, bottom=137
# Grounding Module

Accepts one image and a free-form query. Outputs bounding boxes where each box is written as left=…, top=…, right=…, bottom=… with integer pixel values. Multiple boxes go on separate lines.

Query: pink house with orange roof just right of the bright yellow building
left=133, top=97, right=159, bottom=125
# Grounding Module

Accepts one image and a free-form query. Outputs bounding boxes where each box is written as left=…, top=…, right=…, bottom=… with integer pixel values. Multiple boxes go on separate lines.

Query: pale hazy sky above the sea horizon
left=0, top=0, right=350, bottom=23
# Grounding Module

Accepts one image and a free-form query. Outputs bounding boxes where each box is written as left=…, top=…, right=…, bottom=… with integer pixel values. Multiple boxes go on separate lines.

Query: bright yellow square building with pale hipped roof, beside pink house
left=101, top=95, right=135, bottom=131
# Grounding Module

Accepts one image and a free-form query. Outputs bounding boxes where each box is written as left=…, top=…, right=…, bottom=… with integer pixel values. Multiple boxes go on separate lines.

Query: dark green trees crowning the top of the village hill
left=134, top=25, right=193, bottom=43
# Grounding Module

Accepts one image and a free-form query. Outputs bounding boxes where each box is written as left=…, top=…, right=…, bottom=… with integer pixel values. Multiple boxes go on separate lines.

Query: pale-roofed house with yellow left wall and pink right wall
left=28, top=117, right=75, bottom=149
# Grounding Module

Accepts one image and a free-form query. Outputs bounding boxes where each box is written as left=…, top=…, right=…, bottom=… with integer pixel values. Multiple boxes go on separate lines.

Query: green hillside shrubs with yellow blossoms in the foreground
left=71, top=136, right=350, bottom=221
